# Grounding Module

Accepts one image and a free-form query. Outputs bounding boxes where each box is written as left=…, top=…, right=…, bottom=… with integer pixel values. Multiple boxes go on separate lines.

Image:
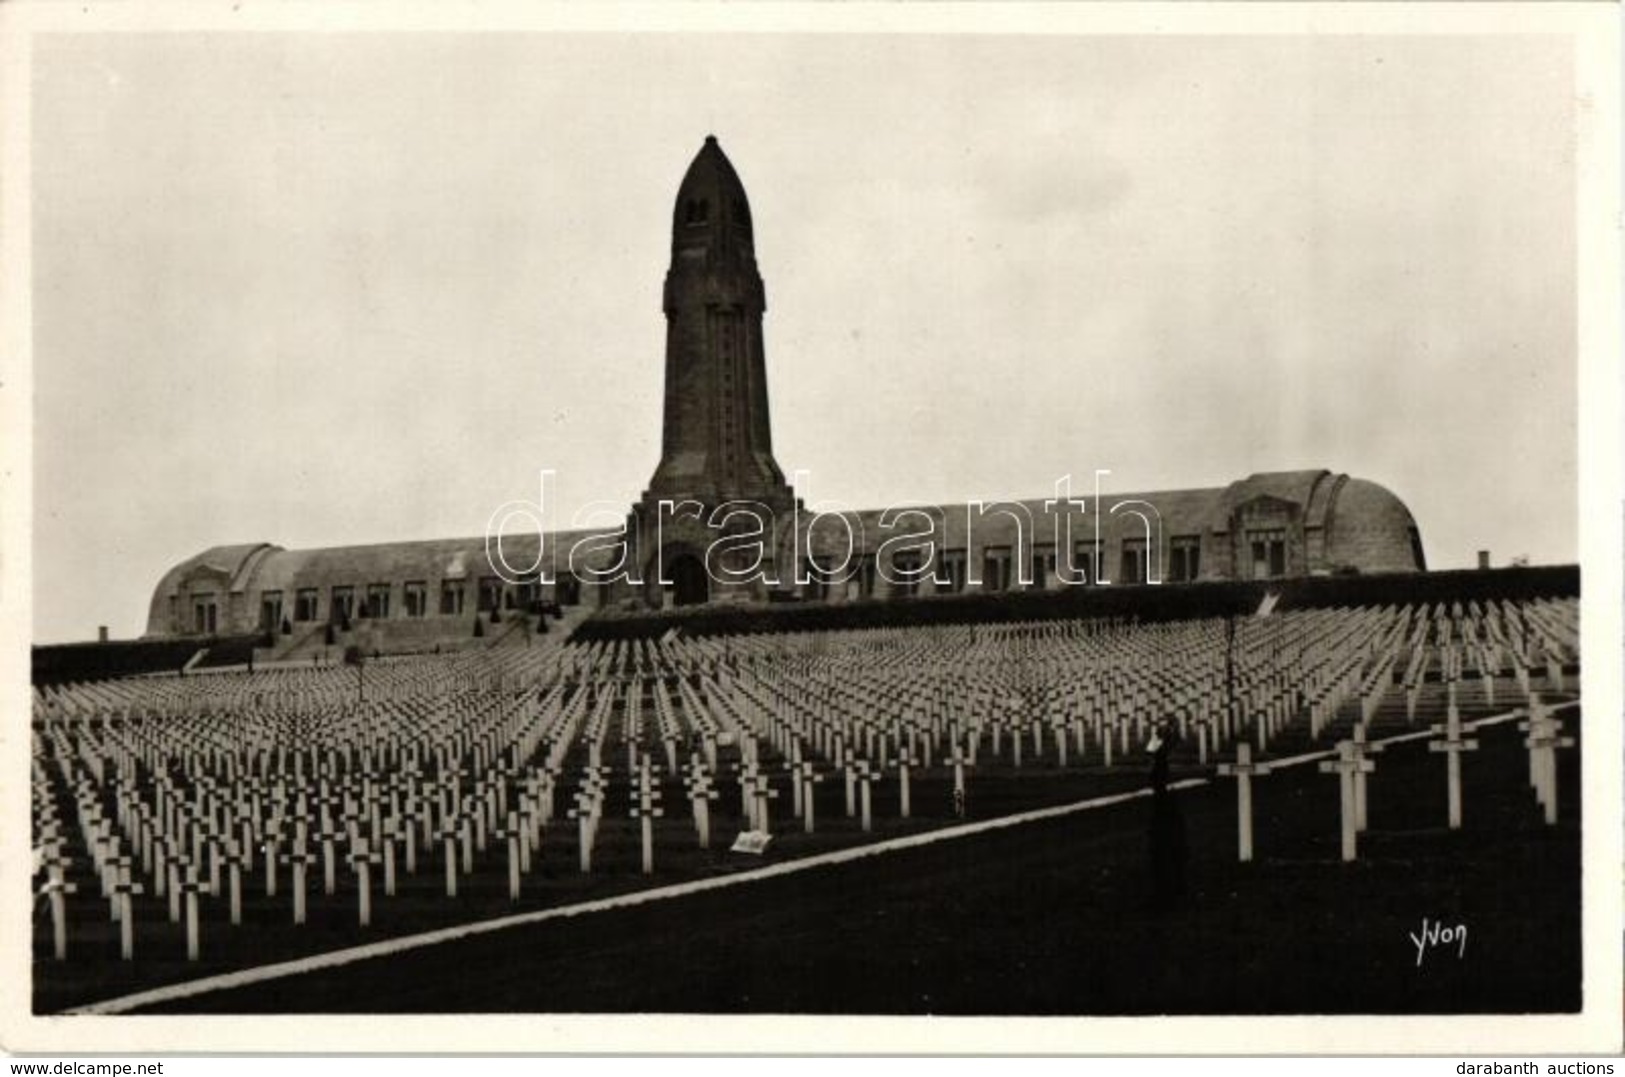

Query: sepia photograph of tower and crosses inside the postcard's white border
left=11, top=21, right=1619, bottom=1039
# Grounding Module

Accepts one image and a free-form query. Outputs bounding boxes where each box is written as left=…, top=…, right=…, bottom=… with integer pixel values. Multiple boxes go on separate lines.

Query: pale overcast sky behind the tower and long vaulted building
left=33, top=34, right=1578, bottom=642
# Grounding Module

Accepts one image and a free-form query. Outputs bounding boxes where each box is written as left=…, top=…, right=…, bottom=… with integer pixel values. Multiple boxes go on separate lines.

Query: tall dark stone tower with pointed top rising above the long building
left=634, top=136, right=793, bottom=603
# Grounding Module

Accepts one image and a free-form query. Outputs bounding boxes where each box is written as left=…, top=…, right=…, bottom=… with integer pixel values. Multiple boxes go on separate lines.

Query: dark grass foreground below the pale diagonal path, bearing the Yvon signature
left=98, top=710, right=1581, bottom=1015
